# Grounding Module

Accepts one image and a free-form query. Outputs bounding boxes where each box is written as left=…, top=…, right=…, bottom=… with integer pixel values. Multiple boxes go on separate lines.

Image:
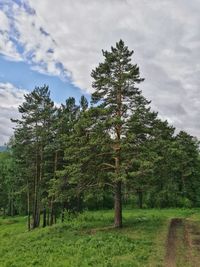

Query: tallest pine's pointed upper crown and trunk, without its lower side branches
left=91, top=40, right=149, bottom=227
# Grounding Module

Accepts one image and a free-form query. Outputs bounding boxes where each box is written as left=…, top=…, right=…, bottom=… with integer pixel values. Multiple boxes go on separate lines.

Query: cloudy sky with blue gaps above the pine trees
left=0, top=0, right=200, bottom=145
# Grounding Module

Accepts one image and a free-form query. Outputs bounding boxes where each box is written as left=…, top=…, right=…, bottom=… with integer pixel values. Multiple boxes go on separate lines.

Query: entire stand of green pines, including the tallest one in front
left=0, top=40, right=200, bottom=229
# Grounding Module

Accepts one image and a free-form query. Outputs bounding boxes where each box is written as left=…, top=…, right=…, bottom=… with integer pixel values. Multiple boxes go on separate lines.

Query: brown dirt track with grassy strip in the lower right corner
left=164, top=218, right=200, bottom=267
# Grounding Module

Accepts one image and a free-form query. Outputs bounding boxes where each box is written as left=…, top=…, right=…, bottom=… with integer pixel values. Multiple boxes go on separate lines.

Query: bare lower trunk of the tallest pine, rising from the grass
left=114, top=182, right=122, bottom=228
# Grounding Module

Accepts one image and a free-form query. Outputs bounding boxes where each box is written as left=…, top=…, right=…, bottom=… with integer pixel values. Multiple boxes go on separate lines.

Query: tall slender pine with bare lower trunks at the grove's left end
left=13, top=85, right=55, bottom=228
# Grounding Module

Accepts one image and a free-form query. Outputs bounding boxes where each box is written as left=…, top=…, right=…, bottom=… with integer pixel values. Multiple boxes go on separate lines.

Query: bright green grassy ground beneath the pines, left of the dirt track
left=0, top=209, right=200, bottom=267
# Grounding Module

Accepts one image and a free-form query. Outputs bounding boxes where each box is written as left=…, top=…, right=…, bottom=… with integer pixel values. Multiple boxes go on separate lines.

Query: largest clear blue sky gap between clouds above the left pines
left=0, top=56, right=90, bottom=103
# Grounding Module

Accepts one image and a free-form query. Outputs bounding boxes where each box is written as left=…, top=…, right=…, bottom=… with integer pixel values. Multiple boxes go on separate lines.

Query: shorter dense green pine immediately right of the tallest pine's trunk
left=123, top=105, right=158, bottom=208
